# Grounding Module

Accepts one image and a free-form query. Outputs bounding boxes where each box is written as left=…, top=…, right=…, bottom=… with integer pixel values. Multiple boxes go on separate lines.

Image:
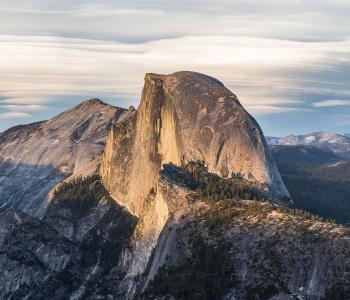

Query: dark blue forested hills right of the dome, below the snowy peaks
left=270, top=145, right=350, bottom=224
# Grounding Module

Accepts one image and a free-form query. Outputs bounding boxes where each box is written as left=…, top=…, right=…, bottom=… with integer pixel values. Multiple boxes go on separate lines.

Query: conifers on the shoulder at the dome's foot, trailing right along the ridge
left=165, top=161, right=335, bottom=225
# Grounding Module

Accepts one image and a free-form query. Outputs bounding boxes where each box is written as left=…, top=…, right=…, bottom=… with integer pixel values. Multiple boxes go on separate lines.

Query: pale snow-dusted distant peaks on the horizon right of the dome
left=266, top=131, right=350, bottom=159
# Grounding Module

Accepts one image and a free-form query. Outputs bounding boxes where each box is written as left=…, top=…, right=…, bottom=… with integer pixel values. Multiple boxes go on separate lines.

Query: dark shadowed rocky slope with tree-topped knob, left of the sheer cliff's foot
left=0, top=176, right=136, bottom=299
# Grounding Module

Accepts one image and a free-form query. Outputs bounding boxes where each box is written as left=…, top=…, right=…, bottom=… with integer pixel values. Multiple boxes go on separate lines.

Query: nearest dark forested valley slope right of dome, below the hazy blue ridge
left=277, top=160, right=350, bottom=224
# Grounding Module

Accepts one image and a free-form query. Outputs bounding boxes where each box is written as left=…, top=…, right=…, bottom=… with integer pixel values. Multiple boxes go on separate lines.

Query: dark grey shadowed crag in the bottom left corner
left=0, top=209, right=78, bottom=299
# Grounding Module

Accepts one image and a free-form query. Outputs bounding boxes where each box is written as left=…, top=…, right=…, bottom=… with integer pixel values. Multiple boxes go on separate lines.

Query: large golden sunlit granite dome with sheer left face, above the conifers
left=101, top=72, right=289, bottom=215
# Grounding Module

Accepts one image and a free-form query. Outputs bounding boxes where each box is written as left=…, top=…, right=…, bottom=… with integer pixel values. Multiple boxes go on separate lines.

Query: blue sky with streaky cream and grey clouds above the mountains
left=0, top=0, right=350, bottom=136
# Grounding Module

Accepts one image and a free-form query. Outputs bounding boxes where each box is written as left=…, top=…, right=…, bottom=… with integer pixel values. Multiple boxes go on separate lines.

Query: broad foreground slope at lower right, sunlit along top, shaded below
left=139, top=197, right=350, bottom=300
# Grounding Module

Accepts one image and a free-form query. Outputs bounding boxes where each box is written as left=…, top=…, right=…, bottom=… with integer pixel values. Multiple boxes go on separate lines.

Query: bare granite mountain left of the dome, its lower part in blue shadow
left=0, top=99, right=124, bottom=215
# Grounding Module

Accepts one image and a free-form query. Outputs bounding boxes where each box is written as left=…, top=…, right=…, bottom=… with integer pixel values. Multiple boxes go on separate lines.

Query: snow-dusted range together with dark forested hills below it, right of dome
left=266, top=131, right=350, bottom=224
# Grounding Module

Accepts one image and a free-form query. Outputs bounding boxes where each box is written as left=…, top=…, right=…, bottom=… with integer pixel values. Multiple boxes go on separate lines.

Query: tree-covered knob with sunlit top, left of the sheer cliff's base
left=52, top=175, right=108, bottom=217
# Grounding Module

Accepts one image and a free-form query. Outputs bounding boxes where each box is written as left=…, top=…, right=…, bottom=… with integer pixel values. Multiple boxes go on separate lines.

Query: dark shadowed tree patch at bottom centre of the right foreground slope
left=143, top=235, right=234, bottom=300
